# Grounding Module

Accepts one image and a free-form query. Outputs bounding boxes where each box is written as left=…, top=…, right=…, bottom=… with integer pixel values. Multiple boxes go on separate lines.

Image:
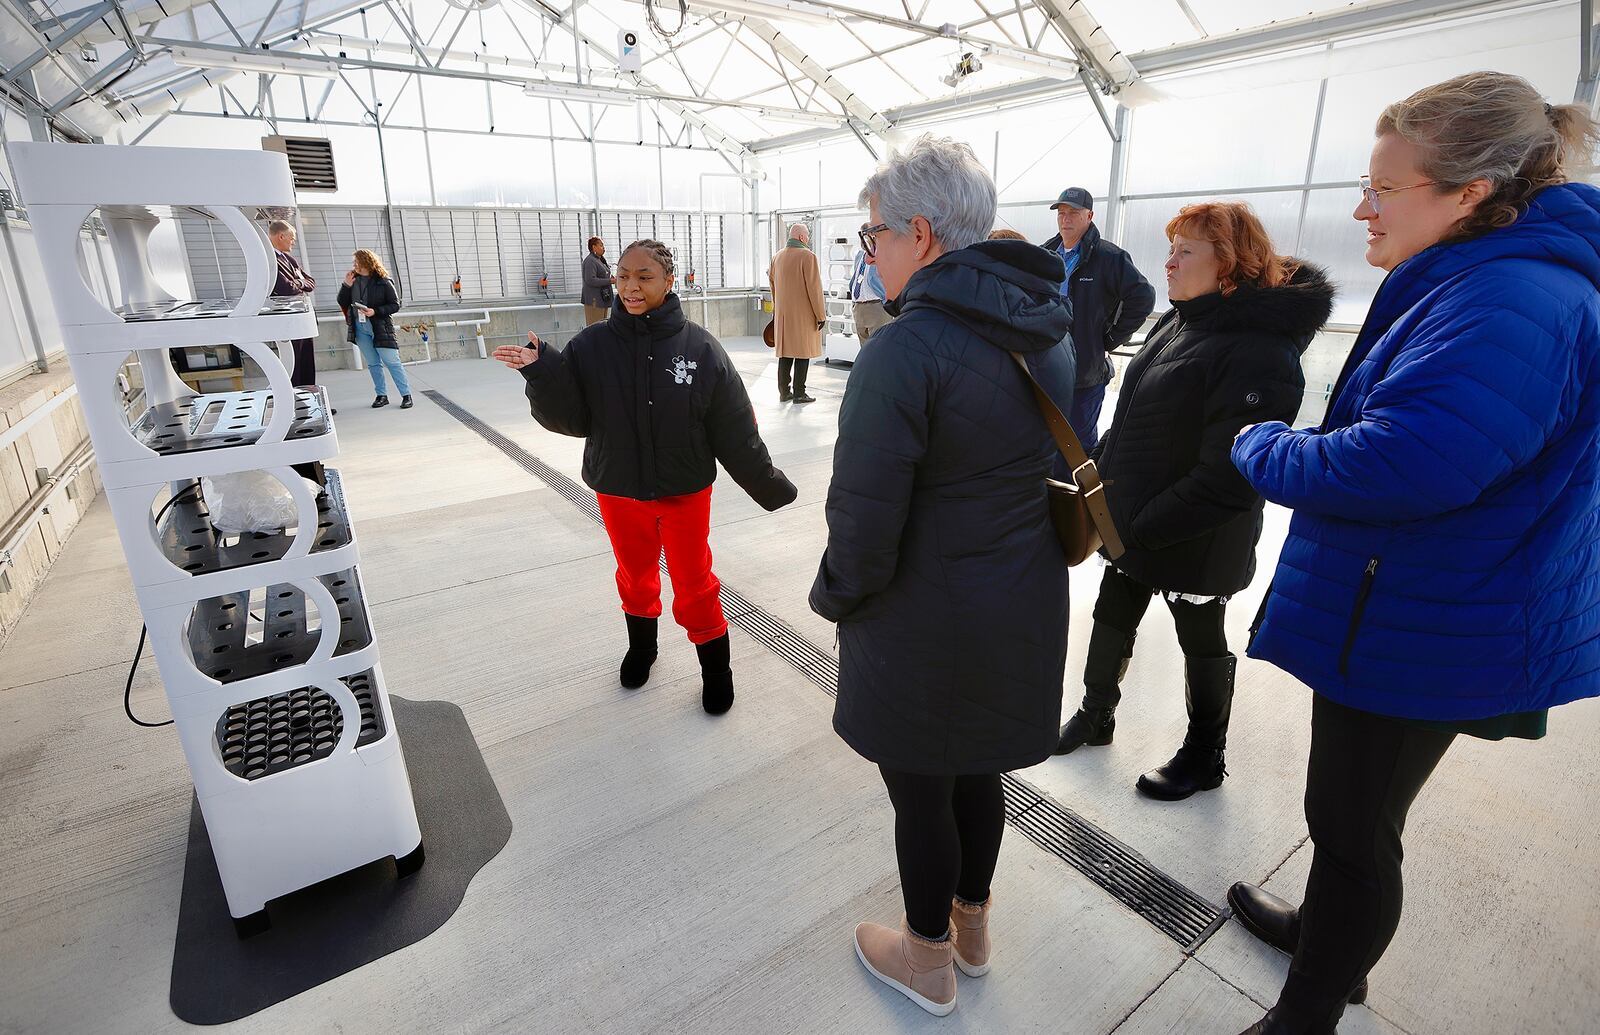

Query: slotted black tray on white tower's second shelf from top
left=130, top=389, right=333, bottom=456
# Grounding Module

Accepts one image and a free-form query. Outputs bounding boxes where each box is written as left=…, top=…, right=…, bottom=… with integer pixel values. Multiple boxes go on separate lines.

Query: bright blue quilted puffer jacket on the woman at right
left=1234, top=184, right=1600, bottom=720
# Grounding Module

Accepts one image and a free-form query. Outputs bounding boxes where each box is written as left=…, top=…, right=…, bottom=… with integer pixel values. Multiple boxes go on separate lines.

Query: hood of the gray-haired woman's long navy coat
left=894, top=240, right=1072, bottom=352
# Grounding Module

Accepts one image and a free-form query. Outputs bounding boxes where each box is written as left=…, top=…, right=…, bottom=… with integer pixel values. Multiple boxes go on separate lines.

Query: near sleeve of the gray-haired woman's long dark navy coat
left=811, top=323, right=938, bottom=622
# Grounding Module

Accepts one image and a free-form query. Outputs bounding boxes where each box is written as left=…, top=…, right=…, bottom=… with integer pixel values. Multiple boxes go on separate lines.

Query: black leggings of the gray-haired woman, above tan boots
left=878, top=766, right=1005, bottom=939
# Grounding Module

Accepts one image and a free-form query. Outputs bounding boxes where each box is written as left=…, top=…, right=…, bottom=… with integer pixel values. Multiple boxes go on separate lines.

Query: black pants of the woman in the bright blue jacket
left=1277, top=694, right=1456, bottom=1032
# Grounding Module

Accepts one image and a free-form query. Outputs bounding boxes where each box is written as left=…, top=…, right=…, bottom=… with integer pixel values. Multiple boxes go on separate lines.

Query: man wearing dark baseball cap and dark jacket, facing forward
left=1045, top=187, right=1155, bottom=450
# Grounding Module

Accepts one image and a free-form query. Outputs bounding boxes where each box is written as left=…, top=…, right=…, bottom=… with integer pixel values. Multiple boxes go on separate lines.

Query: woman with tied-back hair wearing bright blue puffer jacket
left=1229, top=72, right=1600, bottom=1035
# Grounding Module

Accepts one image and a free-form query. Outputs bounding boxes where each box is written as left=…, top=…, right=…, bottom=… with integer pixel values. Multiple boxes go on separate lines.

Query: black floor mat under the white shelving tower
left=171, top=697, right=510, bottom=1024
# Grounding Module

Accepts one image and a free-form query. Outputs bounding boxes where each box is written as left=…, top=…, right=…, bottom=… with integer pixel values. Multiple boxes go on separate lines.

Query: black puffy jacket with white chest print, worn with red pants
left=522, top=294, right=797, bottom=510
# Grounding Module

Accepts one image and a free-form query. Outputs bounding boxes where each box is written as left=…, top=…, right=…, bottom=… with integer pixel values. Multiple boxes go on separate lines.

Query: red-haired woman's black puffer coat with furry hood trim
left=1094, top=264, right=1334, bottom=597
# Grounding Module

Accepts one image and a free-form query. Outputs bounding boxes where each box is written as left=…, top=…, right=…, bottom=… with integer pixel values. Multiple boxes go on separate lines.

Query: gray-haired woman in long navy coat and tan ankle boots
left=811, top=136, right=1074, bottom=1014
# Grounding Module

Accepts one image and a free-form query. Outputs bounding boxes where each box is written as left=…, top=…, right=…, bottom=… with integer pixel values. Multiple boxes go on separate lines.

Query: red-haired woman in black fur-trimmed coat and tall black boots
left=1056, top=202, right=1333, bottom=801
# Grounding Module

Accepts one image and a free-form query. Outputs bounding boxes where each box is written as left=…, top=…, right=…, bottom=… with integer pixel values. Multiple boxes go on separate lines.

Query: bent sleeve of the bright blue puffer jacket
left=1234, top=275, right=1574, bottom=523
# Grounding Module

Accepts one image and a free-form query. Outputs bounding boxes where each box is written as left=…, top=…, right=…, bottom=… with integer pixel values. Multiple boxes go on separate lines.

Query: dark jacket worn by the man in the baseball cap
left=1045, top=222, right=1155, bottom=389
